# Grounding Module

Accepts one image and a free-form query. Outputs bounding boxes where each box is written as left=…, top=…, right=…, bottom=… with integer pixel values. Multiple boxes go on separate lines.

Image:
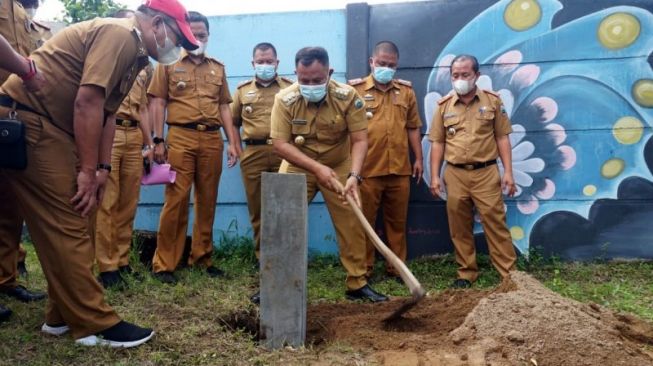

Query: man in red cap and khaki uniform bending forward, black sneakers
left=0, top=0, right=197, bottom=347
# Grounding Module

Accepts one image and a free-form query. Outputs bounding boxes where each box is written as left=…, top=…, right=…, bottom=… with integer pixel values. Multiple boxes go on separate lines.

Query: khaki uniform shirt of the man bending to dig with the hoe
left=271, top=80, right=367, bottom=167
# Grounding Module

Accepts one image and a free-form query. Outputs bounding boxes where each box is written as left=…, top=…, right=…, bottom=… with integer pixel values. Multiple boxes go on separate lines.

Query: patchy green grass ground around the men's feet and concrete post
left=0, top=240, right=653, bottom=366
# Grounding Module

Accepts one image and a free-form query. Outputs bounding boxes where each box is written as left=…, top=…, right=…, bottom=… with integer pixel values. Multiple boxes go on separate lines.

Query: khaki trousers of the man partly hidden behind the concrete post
left=240, top=145, right=281, bottom=259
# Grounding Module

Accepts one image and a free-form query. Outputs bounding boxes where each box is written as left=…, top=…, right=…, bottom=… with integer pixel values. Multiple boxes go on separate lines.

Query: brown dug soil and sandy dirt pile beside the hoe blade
left=307, top=272, right=653, bottom=366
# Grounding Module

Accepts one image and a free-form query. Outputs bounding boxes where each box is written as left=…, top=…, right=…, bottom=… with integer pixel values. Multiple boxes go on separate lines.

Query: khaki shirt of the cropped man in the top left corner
left=0, top=0, right=38, bottom=85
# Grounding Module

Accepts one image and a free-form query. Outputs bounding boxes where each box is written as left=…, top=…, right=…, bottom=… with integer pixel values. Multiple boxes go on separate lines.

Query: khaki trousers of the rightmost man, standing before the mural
left=444, top=165, right=517, bottom=282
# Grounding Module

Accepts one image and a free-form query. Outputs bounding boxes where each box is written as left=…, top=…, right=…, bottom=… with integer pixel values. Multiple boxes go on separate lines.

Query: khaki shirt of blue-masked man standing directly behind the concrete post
left=231, top=76, right=293, bottom=140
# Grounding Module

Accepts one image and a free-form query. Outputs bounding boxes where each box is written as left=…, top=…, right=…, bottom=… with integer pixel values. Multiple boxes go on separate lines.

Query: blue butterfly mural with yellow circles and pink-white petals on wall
left=423, top=0, right=653, bottom=259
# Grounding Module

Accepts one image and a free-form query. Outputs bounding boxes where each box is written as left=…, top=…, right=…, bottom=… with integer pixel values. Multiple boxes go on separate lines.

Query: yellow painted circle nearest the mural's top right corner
left=597, top=13, right=641, bottom=50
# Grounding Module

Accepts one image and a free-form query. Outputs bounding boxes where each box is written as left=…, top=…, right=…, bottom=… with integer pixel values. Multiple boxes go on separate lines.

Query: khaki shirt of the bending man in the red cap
left=2, top=18, right=148, bottom=135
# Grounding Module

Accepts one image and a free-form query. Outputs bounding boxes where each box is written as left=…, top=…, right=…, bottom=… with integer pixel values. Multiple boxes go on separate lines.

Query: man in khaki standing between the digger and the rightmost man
left=349, top=41, right=423, bottom=278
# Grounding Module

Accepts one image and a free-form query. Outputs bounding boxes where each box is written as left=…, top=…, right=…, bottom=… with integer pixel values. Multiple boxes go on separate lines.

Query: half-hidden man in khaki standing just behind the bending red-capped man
left=95, top=10, right=152, bottom=288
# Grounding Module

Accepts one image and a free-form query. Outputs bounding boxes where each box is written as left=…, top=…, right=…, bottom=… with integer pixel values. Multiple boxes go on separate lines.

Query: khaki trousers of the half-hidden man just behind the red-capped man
left=95, top=126, right=143, bottom=272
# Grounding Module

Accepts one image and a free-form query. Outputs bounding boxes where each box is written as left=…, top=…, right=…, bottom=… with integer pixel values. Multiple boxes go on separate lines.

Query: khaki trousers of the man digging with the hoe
left=287, top=160, right=367, bottom=290
